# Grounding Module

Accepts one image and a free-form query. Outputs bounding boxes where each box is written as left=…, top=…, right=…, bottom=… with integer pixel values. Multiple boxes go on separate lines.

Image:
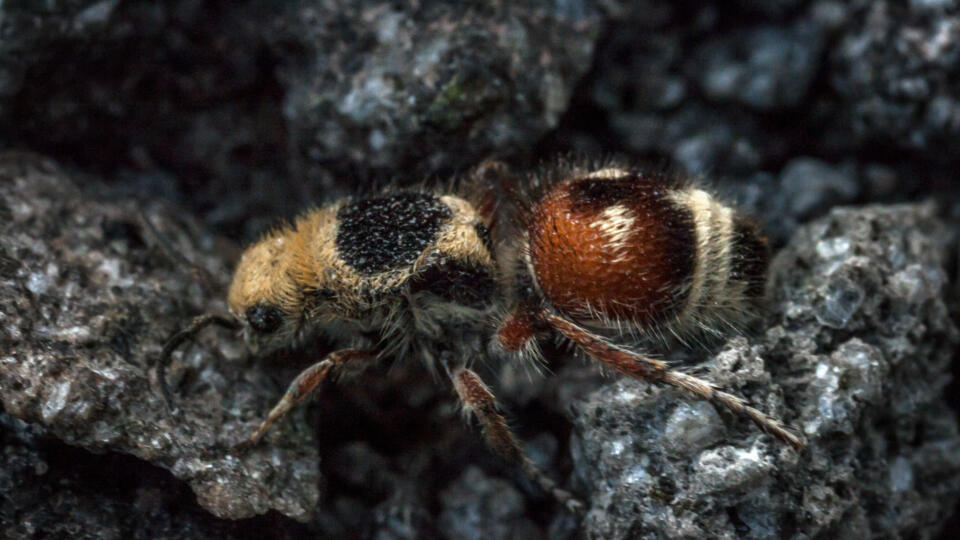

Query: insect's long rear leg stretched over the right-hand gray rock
left=540, top=310, right=804, bottom=450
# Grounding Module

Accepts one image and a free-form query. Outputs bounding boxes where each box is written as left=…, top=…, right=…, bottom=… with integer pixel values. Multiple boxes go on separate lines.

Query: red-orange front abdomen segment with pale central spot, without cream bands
left=528, top=173, right=696, bottom=325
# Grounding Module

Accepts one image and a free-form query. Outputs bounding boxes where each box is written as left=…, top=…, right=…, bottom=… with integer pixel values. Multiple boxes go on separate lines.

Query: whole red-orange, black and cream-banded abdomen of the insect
left=527, top=169, right=766, bottom=333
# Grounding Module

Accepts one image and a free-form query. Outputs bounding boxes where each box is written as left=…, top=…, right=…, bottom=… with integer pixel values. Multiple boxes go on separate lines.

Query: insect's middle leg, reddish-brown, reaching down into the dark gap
left=451, top=368, right=584, bottom=513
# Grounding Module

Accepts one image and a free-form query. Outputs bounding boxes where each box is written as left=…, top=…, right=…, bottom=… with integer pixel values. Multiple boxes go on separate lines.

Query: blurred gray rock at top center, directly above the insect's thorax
left=279, top=0, right=601, bottom=178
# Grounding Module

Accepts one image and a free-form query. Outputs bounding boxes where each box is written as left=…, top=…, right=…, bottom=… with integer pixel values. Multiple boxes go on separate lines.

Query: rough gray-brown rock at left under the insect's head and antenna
left=0, top=153, right=319, bottom=520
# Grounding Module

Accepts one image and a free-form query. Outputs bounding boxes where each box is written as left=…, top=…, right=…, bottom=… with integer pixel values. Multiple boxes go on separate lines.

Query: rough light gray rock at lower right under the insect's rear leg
left=574, top=204, right=960, bottom=538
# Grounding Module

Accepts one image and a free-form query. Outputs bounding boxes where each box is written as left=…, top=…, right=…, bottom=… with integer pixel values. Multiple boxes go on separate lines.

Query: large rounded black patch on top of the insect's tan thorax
left=337, top=193, right=453, bottom=276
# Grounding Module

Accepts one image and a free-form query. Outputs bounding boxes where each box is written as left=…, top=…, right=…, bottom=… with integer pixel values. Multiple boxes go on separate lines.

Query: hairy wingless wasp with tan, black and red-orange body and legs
left=157, top=163, right=804, bottom=510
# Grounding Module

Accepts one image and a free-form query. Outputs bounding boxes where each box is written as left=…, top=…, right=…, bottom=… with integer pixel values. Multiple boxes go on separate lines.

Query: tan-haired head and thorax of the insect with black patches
left=222, top=187, right=497, bottom=362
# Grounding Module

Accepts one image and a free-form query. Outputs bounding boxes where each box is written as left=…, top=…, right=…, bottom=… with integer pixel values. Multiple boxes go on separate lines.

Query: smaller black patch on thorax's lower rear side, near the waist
left=410, top=257, right=496, bottom=309
